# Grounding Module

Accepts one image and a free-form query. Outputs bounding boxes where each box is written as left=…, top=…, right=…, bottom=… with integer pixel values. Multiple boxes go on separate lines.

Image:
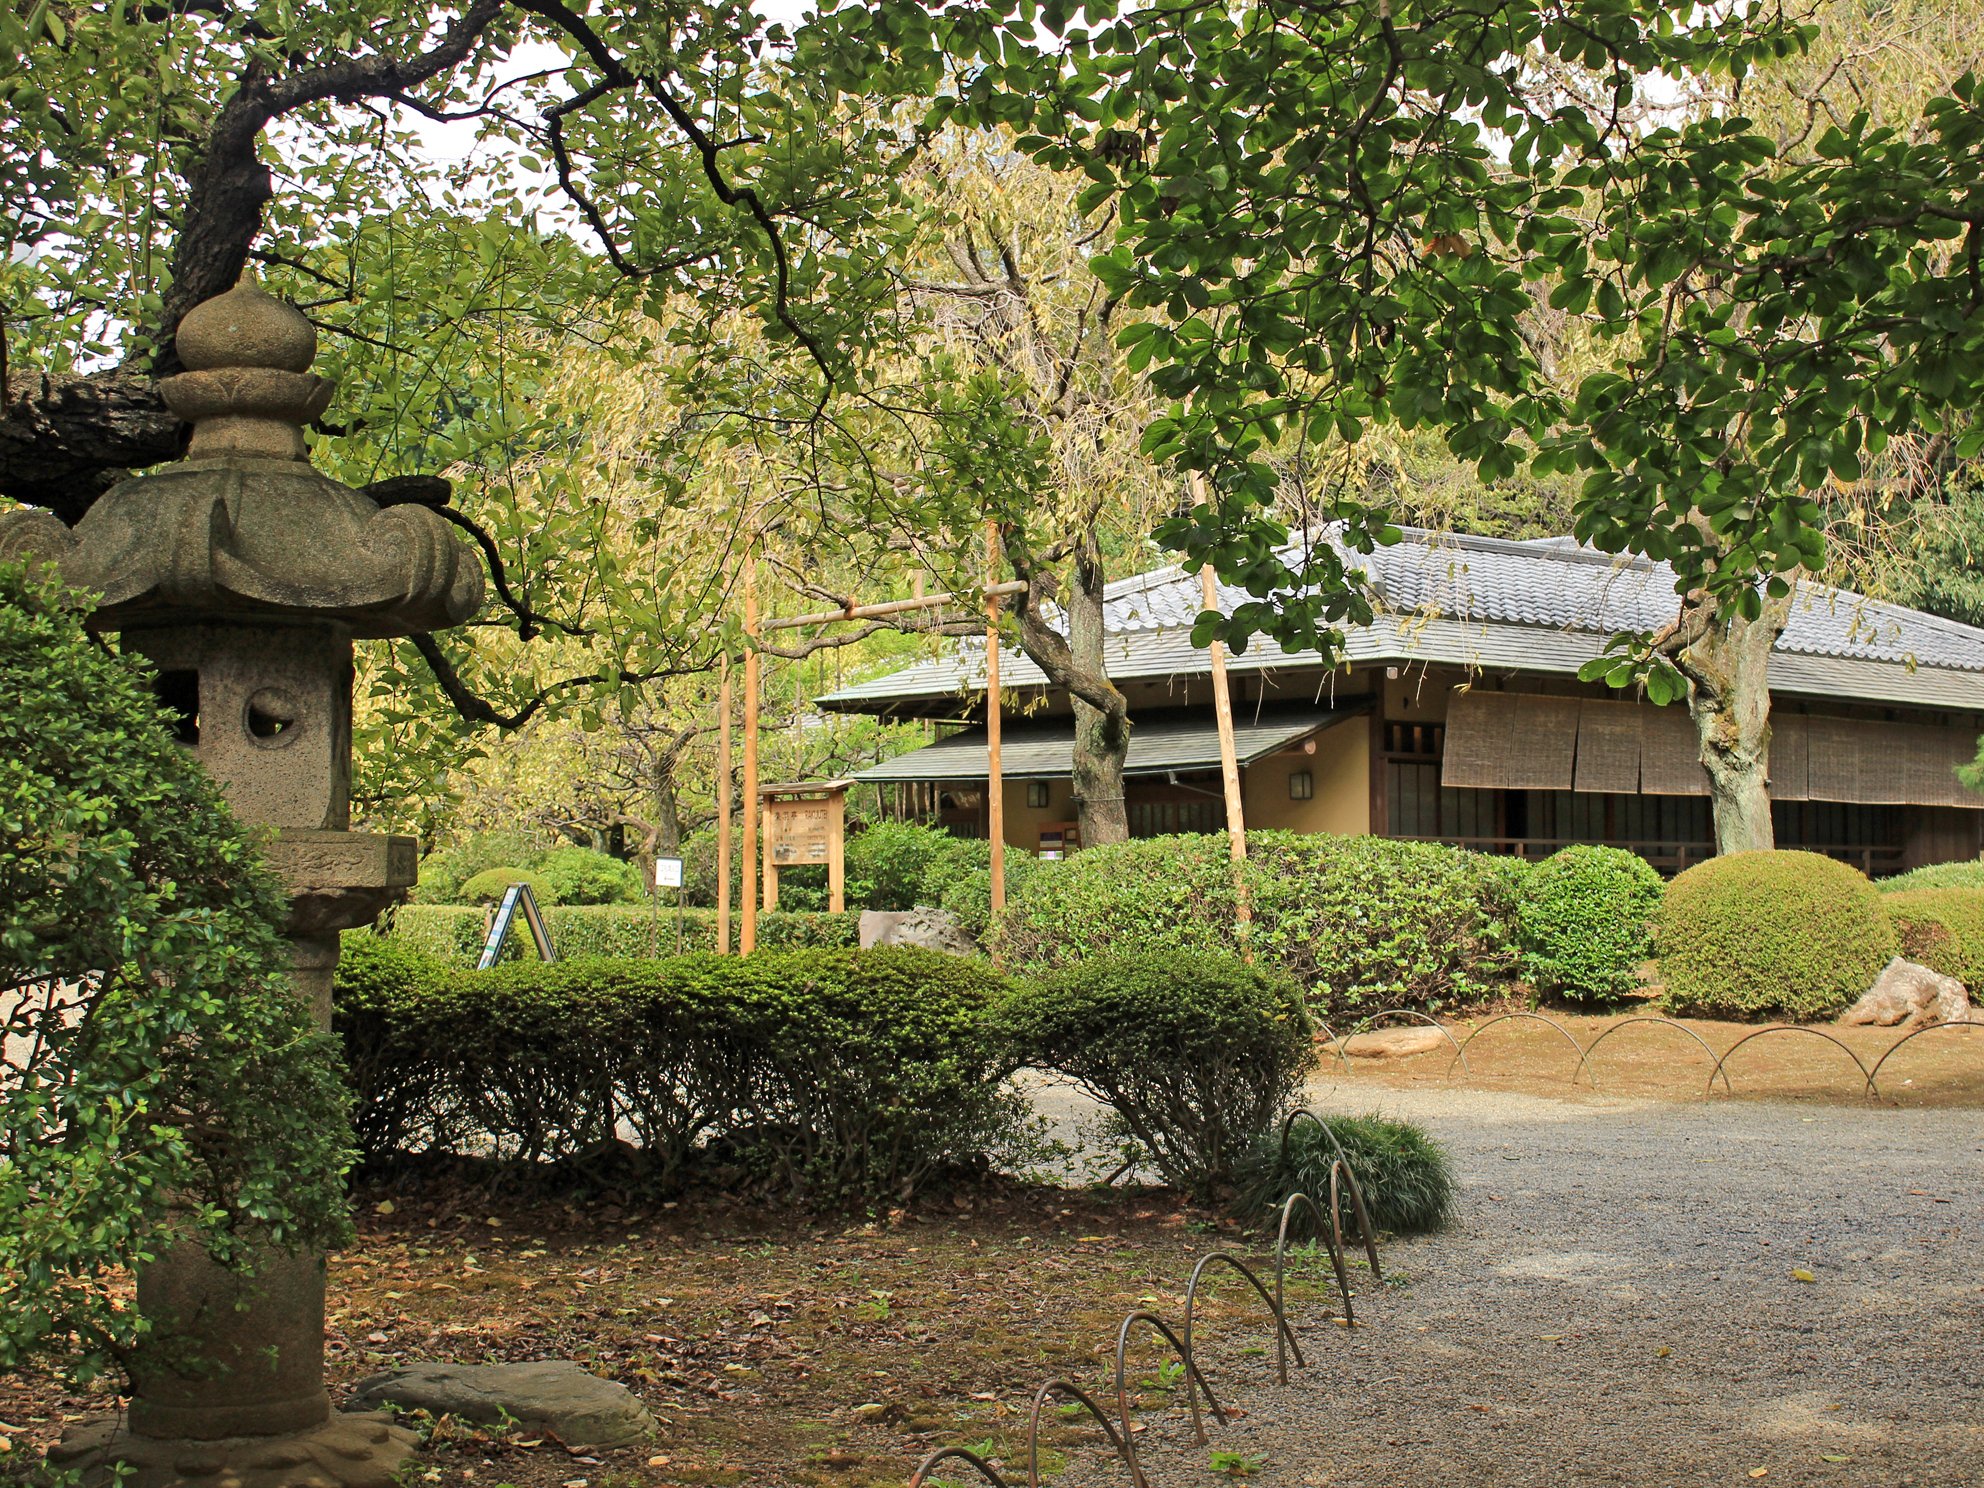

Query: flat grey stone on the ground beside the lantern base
left=351, top=1359, right=655, bottom=1450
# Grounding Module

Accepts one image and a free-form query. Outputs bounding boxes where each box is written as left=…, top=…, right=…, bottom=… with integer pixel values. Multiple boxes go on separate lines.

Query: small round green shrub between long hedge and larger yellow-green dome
left=1516, top=845, right=1663, bottom=1002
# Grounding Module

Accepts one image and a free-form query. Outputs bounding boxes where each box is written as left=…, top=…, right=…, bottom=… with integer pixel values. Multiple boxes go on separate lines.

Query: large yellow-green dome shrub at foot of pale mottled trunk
left=1655, top=851, right=1899, bottom=1020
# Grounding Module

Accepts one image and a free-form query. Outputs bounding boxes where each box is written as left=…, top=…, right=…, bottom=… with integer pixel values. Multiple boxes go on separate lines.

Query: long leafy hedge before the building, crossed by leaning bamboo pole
left=996, top=831, right=1524, bottom=1018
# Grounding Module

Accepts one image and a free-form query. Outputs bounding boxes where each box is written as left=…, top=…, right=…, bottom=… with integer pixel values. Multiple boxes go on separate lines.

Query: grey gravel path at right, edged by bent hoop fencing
left=1069, top=1087, right=1984, bottom=1488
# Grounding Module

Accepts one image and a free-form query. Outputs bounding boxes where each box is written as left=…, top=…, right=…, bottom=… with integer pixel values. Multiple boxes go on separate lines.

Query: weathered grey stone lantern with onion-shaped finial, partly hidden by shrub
left=0, top=282, right=482, bottom=1488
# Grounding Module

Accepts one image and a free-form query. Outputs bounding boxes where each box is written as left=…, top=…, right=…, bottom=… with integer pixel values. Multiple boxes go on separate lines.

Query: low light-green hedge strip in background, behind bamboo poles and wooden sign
left=391, top=905, right=861, bottom=966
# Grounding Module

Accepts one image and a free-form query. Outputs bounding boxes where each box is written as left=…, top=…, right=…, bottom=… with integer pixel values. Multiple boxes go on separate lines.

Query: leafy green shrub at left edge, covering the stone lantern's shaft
left=0, top=565, right=349, bottom=1377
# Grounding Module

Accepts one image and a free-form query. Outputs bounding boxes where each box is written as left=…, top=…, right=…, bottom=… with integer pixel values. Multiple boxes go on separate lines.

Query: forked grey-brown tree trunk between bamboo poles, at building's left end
left=1014, top=534, right=1131, bottom=847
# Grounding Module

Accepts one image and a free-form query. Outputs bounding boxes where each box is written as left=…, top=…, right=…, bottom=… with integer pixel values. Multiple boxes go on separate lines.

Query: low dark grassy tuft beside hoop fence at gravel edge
left=1234, top=1115, right=1458, bottom=1238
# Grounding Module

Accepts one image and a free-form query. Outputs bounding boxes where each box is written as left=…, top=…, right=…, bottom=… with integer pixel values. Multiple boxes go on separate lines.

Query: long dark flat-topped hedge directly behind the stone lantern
left=335, top=948, right=1022, bottom=1198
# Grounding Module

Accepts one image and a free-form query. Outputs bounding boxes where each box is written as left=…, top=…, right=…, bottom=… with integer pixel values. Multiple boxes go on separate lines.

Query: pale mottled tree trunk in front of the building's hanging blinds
left=1674, top=595, right=1792, bottom=855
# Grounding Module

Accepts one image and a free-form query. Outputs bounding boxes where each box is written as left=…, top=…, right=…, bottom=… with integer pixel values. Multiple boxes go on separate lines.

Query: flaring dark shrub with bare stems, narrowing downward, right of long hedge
left=1000, top=952, right=1315, bottom=1198
